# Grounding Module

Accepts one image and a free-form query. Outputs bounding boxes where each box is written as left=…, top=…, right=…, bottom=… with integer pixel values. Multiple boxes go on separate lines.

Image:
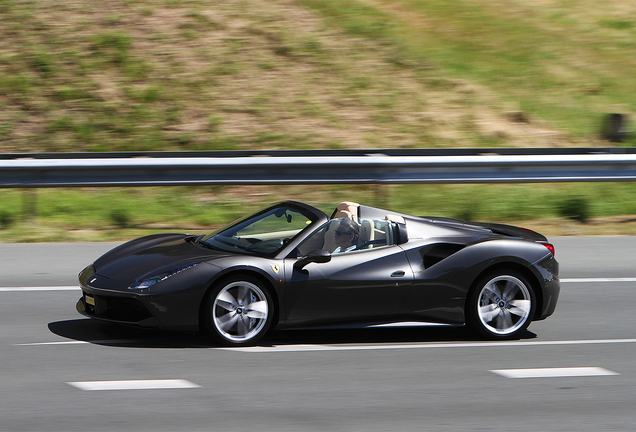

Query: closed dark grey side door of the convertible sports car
left=284, top=245, right=413, bottom=325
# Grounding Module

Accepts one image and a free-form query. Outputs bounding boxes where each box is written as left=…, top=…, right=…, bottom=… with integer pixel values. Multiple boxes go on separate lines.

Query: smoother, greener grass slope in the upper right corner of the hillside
left=302, top=0, right=636, bottom=137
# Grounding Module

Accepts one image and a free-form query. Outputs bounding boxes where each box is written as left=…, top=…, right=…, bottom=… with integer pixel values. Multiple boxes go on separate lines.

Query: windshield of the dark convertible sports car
left=200, top=205, right=317, bottom=256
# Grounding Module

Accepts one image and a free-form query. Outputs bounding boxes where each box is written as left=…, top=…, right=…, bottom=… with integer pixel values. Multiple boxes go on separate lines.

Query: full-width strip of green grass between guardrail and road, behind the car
left=0, top=183, right=636, bottom=242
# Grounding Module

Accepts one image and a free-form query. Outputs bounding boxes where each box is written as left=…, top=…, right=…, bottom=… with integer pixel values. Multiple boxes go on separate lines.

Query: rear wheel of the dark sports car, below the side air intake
left=466, top=270, right=536, bottom=339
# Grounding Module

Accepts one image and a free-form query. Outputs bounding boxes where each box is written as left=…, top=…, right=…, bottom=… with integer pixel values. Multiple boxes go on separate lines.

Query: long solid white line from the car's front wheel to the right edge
left=220, top=339, right=636, bottom=353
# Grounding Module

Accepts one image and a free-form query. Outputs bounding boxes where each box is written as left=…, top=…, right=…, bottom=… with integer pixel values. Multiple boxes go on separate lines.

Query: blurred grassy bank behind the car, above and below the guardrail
left=0, top=0, right=636, bottom=242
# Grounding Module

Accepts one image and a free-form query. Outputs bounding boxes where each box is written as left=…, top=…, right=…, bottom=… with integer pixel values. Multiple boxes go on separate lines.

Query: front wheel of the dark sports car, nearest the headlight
left=205, top=276, right=274, bottom=346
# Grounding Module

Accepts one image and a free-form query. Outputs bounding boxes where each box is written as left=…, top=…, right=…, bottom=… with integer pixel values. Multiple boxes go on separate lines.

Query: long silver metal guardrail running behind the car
left=0, top=148, right=636, bottom=188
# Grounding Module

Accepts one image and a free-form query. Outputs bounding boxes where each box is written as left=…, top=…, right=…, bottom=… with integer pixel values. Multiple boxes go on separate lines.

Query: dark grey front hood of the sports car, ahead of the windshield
left=93, top=234, right=228, bottom=283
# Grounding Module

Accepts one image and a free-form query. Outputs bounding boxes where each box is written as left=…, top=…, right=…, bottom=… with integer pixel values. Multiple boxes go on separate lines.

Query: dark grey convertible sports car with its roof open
left=77, top=201, right=560, bottom=346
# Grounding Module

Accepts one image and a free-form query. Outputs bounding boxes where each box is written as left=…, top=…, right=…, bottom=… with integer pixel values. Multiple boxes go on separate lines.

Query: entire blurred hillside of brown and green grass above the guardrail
left=0, top=0, right=636, bottom=152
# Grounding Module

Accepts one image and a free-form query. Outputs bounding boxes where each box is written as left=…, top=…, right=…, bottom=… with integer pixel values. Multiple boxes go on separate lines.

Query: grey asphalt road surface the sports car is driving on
left=0, top=237, right=636, bottom=431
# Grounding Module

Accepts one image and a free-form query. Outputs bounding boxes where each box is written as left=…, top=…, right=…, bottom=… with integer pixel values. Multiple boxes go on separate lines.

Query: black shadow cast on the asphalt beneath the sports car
left=48, top=319, right=537, bottom=349
